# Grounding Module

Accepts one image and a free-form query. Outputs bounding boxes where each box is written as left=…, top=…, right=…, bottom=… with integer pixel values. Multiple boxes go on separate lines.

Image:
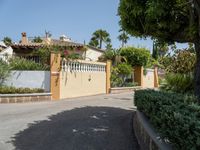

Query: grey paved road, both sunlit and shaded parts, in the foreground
left=0, top=93, right=139, bottom=150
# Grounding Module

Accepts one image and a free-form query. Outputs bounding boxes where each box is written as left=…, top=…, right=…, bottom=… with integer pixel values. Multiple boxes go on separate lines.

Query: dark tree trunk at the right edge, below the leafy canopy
left=194, top=42, right=200, bottom=104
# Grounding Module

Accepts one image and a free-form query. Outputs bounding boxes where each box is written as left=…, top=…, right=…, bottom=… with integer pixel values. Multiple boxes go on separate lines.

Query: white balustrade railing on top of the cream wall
left=61, top=60, right=106, bottom=72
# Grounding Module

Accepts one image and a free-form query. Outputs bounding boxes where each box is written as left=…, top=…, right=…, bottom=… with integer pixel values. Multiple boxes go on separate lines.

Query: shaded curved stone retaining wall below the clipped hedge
left=133, top=111, right=172, bottom=150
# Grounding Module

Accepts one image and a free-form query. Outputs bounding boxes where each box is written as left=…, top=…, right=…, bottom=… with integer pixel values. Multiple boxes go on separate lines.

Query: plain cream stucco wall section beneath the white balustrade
left=60, top=71, right=106, bottom=99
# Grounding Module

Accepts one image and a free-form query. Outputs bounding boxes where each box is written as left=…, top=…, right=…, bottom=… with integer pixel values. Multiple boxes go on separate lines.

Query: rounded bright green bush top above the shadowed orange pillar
left=121, top=47, right=151, bottom=67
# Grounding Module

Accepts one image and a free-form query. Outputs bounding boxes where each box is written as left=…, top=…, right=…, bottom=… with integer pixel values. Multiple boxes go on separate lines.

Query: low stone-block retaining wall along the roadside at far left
left=0, top=93, right=51, bottom=104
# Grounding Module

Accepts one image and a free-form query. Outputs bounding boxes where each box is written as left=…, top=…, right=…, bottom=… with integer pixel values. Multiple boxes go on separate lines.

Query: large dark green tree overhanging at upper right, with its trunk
left=118, top=0, right=200, bottom=99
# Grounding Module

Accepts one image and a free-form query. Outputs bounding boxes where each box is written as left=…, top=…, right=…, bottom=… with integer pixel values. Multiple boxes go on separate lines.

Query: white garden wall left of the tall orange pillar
left=4, top=71, right=50, bottom=92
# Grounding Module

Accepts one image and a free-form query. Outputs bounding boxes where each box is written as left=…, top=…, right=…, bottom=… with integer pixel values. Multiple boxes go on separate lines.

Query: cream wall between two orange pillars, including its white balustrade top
left=60, top=61, right=106, bottom=99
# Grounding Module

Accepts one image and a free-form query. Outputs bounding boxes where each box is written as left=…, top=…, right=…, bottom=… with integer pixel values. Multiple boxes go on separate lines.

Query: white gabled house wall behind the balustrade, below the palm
left=85, top=47, right=103, bottom=61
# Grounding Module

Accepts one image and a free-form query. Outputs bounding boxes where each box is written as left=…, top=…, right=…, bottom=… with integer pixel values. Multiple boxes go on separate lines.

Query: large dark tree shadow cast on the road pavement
left=12, top=107, right=139, bottom=150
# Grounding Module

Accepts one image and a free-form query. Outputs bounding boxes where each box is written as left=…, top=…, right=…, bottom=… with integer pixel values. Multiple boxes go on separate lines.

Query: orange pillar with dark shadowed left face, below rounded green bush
left=134, top=66, right=144, bottom=87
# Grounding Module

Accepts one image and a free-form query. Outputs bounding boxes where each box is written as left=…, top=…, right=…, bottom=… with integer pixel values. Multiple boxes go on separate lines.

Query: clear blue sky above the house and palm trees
left=0, top=0, right=188, bottom=49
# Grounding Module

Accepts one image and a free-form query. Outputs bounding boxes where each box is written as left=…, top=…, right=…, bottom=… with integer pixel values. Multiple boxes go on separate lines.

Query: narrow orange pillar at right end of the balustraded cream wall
left=106, top=60, right=111, bottom=94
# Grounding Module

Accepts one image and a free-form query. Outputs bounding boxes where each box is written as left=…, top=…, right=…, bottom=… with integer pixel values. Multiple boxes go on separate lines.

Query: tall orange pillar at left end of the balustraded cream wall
left=50, top=53, right=61, bottom=100
